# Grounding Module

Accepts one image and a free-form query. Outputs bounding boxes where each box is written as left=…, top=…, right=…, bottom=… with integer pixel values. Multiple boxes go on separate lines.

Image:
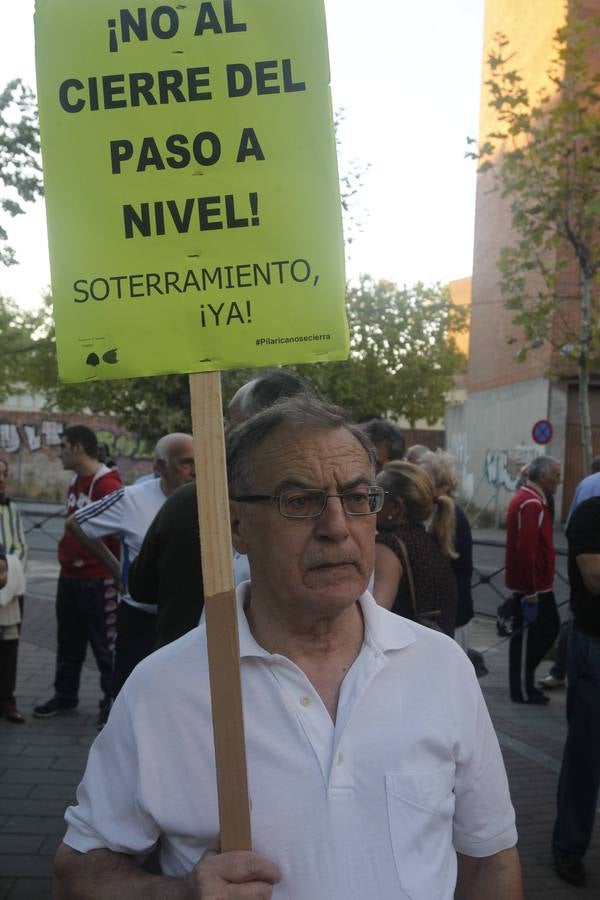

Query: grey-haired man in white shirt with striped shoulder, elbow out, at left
left=61, top=432, right=195, bottom=704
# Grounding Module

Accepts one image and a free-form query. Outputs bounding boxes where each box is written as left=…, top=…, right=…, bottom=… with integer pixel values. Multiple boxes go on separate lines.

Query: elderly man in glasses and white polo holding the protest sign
left=55, top=398, right=522, bottom=900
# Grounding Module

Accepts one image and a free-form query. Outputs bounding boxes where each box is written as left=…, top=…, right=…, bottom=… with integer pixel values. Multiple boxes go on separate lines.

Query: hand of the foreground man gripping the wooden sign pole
left=186, top=848, right=281, bottom=900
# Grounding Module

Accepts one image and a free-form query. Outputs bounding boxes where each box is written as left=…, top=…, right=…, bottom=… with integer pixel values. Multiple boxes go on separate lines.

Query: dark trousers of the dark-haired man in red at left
left=54, top=575, right=115, bottom=706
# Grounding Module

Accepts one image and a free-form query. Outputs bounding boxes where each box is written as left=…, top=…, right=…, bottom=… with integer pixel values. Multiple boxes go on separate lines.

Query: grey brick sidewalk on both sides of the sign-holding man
left=0, top=561, right=600, bottom=900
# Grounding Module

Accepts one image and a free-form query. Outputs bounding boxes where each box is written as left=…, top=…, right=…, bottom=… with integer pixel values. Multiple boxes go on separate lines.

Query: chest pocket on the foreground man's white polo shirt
left=385, top=763, right=456, bottom=900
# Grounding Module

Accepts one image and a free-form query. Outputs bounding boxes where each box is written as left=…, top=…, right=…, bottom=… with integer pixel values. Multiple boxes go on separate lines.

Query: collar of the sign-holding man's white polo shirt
left=236, top=581, right=416, bottom=659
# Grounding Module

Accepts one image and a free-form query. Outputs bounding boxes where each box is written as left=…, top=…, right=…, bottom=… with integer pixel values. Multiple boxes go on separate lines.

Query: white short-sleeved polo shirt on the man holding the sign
left=65, top=582, right=517, bottom=900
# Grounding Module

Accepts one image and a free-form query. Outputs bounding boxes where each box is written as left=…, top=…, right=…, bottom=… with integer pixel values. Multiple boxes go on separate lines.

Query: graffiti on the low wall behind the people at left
left=0, top=419, right=154, bottom=460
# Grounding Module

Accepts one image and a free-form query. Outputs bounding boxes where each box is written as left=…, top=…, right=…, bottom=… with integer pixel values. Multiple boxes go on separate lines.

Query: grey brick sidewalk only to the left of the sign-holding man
left=0, top=561, right=100, bottom=900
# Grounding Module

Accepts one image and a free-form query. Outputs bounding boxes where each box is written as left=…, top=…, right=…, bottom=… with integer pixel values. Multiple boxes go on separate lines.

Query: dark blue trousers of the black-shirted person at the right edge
left=552, top=626, right=600, bottom=859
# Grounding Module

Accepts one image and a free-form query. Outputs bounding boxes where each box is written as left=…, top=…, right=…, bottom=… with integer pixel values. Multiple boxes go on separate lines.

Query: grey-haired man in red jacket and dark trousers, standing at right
left=505, top=456, right=560, bottom=705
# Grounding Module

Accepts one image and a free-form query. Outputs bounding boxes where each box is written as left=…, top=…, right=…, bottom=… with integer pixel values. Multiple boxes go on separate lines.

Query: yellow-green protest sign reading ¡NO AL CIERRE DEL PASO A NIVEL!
left=36, top=0, right=348, bottom=381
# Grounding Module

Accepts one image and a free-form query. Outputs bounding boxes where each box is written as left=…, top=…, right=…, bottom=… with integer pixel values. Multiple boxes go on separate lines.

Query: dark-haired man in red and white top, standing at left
left=33, top=425, right=121, bottom=722
